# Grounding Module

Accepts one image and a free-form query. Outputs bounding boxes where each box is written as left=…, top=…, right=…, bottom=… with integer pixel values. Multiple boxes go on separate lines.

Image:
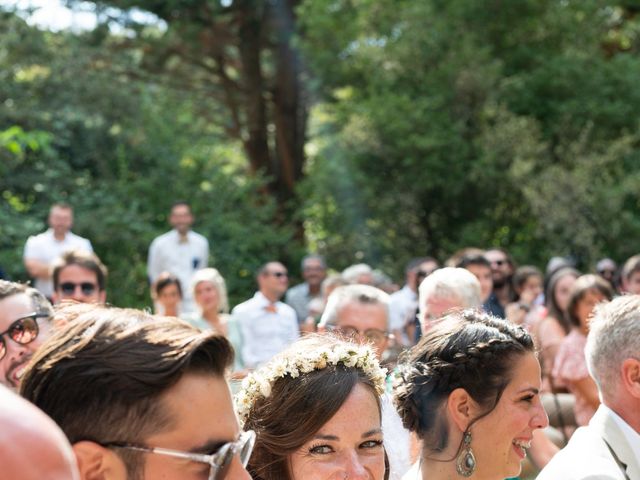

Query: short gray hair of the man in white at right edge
left=585, top=295, right=640, bottom=396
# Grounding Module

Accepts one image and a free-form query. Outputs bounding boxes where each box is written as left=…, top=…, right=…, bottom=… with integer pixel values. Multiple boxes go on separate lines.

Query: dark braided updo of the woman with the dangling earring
left=395, top=310, right=534, bottom=452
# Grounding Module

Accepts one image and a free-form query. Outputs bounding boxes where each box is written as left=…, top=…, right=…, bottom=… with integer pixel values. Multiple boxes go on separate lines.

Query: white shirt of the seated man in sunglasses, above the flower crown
left=231, top=292, right=300, bottom=368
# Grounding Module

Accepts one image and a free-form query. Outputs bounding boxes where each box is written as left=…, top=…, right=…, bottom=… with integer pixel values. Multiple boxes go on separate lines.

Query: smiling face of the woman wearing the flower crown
left=289, top=384, right=385, bottom=480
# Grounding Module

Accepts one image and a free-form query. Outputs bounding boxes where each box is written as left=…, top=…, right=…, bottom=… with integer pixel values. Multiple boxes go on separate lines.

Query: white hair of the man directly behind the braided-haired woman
left=419, top=267, right=482, bottom=318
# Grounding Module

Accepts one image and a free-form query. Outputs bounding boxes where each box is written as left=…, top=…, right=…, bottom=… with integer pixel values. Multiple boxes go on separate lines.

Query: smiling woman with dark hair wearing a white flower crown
left=236, top=335, right=387, bottom=480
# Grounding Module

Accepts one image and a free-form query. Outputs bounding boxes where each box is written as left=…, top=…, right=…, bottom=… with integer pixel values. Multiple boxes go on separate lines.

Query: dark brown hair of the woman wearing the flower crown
left=244, top=335, right=380, bottom=480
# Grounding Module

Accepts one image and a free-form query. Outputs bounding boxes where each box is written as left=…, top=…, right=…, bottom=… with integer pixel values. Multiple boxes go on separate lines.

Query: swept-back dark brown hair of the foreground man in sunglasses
left=21, top=304, right=233, bottom=478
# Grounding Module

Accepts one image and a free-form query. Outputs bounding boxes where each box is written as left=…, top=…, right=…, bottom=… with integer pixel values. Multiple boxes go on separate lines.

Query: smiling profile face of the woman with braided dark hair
left=471, top=353, right=549, bottom=479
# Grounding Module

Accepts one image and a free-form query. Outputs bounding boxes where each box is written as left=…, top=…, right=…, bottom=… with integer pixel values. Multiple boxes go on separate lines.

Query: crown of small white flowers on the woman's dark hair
left=235, top=345, right=387, bottom=424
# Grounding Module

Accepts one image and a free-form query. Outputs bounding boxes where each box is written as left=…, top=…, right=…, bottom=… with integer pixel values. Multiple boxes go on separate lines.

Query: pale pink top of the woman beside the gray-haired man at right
left=552, top=328, right=596, bottom=426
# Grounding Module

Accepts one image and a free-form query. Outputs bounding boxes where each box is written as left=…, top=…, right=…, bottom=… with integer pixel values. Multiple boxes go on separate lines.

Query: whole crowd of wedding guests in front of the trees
left=0, top=202, right=640, bottom=480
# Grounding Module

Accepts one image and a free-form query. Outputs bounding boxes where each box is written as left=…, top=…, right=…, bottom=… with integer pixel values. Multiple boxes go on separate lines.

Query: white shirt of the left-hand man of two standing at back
left=23, top=228, right=93, bottom=297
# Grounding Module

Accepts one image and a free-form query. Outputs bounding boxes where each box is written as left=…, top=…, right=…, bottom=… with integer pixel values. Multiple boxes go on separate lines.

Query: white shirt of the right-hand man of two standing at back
left=147, top=229, right=209, bottom=313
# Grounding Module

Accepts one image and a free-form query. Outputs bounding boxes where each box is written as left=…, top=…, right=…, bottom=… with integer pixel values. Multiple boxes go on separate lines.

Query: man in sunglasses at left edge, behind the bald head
left=0, top=280, right=53, bottom=390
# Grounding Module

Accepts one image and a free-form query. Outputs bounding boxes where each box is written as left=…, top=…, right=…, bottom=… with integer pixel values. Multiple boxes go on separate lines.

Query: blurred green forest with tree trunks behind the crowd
left=0, top=0, right=640, bottom=306
